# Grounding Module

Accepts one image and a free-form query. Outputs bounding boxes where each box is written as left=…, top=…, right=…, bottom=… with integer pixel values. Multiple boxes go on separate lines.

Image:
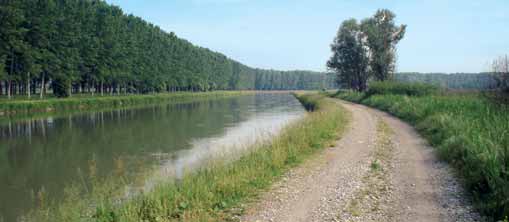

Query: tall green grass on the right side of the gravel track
left=334, top=83, right=509, bottom=220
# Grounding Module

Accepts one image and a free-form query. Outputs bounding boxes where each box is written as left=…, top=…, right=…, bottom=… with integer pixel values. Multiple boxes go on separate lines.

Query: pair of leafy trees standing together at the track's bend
left=327, top=9, right=406, bottom=91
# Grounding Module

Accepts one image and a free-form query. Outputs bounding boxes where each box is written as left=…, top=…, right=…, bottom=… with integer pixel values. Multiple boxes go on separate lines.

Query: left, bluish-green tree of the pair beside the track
left=327, top=19, right=369, bottom=91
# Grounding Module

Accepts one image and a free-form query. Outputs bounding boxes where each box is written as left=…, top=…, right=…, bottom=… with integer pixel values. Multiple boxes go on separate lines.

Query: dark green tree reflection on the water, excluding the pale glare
left=0, top=94, right=300, bottom=220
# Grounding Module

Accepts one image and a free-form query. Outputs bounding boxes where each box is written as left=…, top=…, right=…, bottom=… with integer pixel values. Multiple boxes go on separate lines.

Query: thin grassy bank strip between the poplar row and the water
left=0, top=91, right=253, bottom=116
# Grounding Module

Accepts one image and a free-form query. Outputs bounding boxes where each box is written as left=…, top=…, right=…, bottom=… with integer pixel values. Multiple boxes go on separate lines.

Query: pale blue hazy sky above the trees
left=106, top=0, right=509, bottom=73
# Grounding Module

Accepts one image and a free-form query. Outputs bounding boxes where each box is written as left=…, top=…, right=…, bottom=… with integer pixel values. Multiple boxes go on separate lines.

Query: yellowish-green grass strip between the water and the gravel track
left=29, top=94, right=348, bottom=221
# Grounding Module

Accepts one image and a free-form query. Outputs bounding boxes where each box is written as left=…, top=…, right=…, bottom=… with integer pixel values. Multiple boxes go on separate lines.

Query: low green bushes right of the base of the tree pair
left=366, top=81, right=439, bottom=96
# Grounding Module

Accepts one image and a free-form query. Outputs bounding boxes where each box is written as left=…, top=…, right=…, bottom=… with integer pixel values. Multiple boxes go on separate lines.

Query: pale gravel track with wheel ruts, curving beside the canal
left=241, top=102, right=480, bottom=222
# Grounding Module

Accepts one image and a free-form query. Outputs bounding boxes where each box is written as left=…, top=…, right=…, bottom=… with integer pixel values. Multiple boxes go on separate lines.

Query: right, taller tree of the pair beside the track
left=361, top=9, right=406, bottom=81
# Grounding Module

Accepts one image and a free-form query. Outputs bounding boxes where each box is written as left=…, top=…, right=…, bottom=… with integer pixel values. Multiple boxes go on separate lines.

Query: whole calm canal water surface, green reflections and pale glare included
left=0, top=94, right=305, bottom=221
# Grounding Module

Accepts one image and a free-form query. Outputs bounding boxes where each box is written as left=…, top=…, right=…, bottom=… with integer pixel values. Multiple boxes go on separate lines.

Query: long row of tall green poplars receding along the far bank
left=0, top=0, right=333, bottom=98
